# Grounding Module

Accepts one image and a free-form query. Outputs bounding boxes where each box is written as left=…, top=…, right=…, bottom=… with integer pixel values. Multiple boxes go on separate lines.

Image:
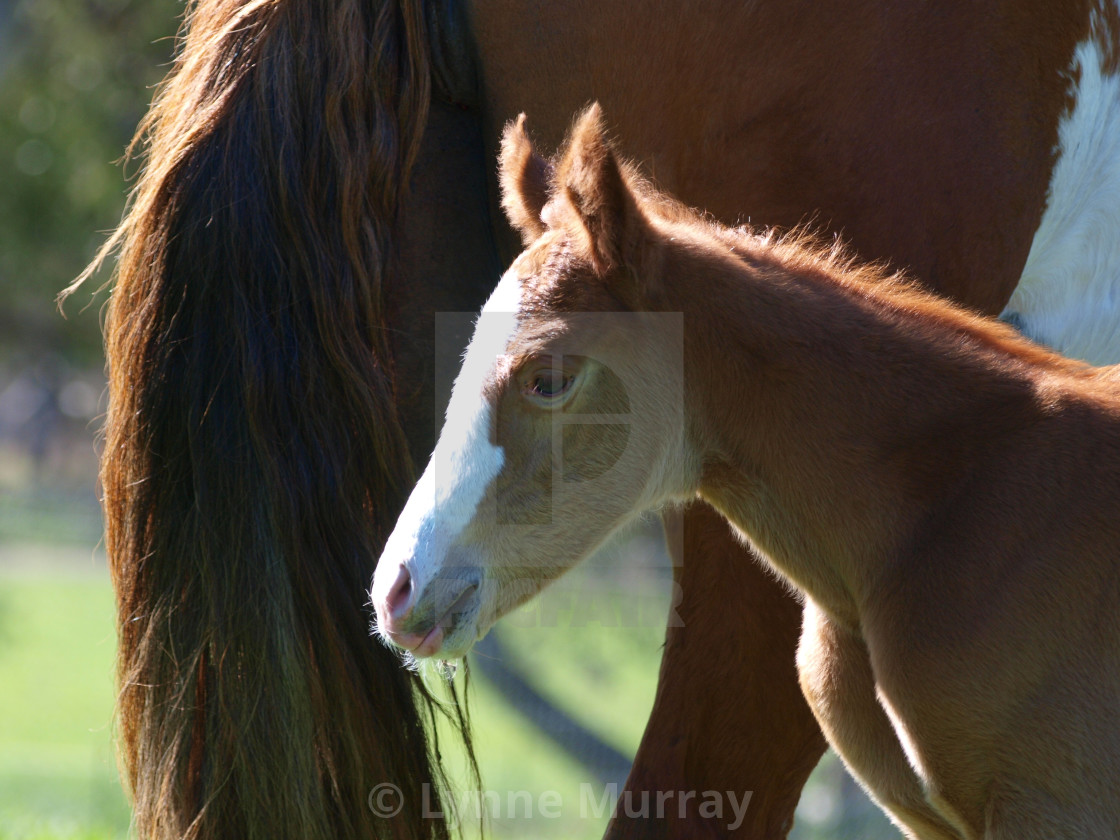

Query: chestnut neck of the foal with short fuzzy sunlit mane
left=659, top=224, right=1061, bottom=622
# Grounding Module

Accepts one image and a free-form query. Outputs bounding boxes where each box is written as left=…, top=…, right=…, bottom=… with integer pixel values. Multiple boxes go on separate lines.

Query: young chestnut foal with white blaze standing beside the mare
left=373, top=106, right=1120, bottom=840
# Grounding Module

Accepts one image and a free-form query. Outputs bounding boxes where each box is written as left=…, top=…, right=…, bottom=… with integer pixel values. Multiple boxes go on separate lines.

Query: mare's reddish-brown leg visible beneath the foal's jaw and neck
left=607, top=504, right=825, bottom=840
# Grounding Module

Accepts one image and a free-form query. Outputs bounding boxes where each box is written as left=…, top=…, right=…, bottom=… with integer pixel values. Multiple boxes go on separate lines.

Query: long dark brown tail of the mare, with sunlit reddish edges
left=65, top=0, right=463, bottom=840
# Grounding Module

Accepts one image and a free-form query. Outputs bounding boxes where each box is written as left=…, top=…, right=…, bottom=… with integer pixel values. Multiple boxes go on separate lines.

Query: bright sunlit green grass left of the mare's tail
left=0, top=545, right=129, bottom=840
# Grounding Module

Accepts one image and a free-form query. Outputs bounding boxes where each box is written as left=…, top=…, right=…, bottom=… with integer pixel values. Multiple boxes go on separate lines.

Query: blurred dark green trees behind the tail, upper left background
left=0, top=0, right=184, bottom=366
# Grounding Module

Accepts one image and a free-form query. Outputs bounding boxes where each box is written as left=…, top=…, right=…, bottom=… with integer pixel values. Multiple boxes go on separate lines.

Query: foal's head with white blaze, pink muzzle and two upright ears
left=372, top=105, right=693, bottom=659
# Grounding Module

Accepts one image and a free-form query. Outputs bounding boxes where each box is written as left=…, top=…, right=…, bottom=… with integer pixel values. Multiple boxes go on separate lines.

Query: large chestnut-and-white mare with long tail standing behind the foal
left=70, top=0, right=1120, bottom=840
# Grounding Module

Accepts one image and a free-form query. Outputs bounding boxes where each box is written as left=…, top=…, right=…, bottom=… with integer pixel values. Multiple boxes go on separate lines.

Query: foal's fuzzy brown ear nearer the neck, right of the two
left=556, top=102, right=641, bottom=274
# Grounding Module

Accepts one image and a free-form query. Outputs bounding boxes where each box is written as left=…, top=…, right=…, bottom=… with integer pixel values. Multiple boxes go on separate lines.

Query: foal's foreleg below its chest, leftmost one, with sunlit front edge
left=797, top=600, right=962, bottom=840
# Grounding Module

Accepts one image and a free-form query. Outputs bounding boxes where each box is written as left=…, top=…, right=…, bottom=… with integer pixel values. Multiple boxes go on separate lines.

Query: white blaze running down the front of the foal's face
left=373, top=269, right=521, bottom=594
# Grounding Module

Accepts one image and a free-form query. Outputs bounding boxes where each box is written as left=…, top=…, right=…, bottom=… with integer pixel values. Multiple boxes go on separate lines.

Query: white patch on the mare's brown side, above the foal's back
left=1001, top=13, right=1120, bottom=365
